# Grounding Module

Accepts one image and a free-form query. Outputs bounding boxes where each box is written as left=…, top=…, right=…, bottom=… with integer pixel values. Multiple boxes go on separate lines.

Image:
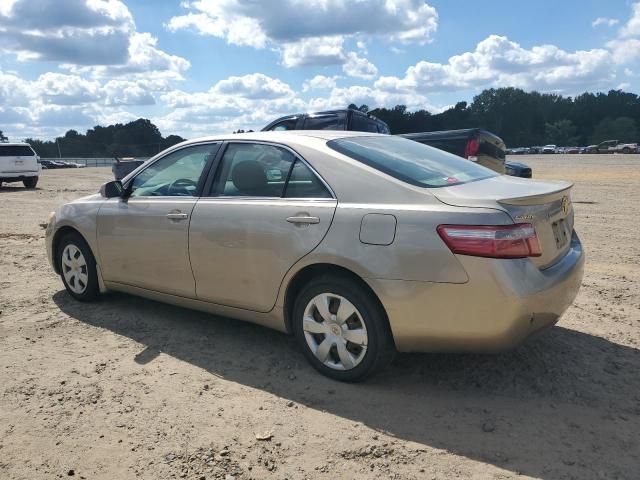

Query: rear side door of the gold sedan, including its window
left=189, top=142, right=337, bottom=312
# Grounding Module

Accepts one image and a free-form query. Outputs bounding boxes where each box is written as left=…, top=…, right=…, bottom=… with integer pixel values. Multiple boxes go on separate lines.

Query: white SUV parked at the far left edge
left=0, top=143, right=40, bottom=188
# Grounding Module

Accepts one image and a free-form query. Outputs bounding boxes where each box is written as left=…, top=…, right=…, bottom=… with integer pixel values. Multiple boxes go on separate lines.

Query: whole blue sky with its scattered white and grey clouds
left=0, top=0, right=640, bottom=140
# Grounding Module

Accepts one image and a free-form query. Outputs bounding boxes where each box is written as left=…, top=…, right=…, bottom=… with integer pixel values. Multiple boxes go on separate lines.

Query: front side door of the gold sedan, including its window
left=97, top=144, right=219, bottom=298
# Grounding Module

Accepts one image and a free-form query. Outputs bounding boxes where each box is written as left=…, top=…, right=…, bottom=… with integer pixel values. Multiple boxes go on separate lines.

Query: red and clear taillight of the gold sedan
left=438, top=223, right=542, bottom=258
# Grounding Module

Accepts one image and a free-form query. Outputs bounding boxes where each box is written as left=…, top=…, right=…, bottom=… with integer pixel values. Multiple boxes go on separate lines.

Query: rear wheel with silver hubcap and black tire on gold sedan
left=292, top=275, right=395, bottom=382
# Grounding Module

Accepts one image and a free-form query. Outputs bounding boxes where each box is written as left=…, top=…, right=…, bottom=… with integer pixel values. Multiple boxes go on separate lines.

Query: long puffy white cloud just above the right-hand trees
left=375, top=35, right=615, bottom=93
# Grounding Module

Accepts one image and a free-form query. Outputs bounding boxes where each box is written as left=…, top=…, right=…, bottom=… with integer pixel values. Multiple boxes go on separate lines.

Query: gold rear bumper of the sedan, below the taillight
left=367, top=234, right=584, bottom=352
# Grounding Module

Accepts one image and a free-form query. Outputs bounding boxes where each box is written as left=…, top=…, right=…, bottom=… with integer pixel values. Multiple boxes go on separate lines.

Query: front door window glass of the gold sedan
left=129, top=144, right=219, bottom=197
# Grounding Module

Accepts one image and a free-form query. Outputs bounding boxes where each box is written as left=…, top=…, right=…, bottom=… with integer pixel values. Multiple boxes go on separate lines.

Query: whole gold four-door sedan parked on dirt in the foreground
left=45, top=131, right=584, bottom=381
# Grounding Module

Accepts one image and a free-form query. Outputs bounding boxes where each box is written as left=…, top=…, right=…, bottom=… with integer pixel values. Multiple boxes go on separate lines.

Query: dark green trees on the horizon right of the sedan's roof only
left=362, top=88, right=640, bottom=147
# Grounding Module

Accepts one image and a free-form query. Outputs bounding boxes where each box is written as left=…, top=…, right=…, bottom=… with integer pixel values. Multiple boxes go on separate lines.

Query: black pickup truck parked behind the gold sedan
left=262, top=109, right=531, bottom=178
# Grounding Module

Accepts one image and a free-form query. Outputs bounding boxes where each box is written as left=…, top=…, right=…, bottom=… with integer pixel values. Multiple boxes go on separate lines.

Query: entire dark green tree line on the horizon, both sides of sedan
left=0, top=88, right=640, bottom=154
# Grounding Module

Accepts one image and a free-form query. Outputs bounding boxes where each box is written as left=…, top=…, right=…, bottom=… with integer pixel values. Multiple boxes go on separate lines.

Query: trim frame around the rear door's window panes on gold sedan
left=200, top=140, right=337, bottom=202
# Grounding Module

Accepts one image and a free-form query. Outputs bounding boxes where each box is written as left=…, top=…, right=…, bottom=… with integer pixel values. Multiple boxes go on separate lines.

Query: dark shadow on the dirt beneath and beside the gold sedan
left=53, top=291, right=640, bottom=479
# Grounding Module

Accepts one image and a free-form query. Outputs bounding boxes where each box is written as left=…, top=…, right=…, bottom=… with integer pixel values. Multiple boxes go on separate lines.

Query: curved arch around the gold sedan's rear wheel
left=283, top=263, right=393, bottom=338
